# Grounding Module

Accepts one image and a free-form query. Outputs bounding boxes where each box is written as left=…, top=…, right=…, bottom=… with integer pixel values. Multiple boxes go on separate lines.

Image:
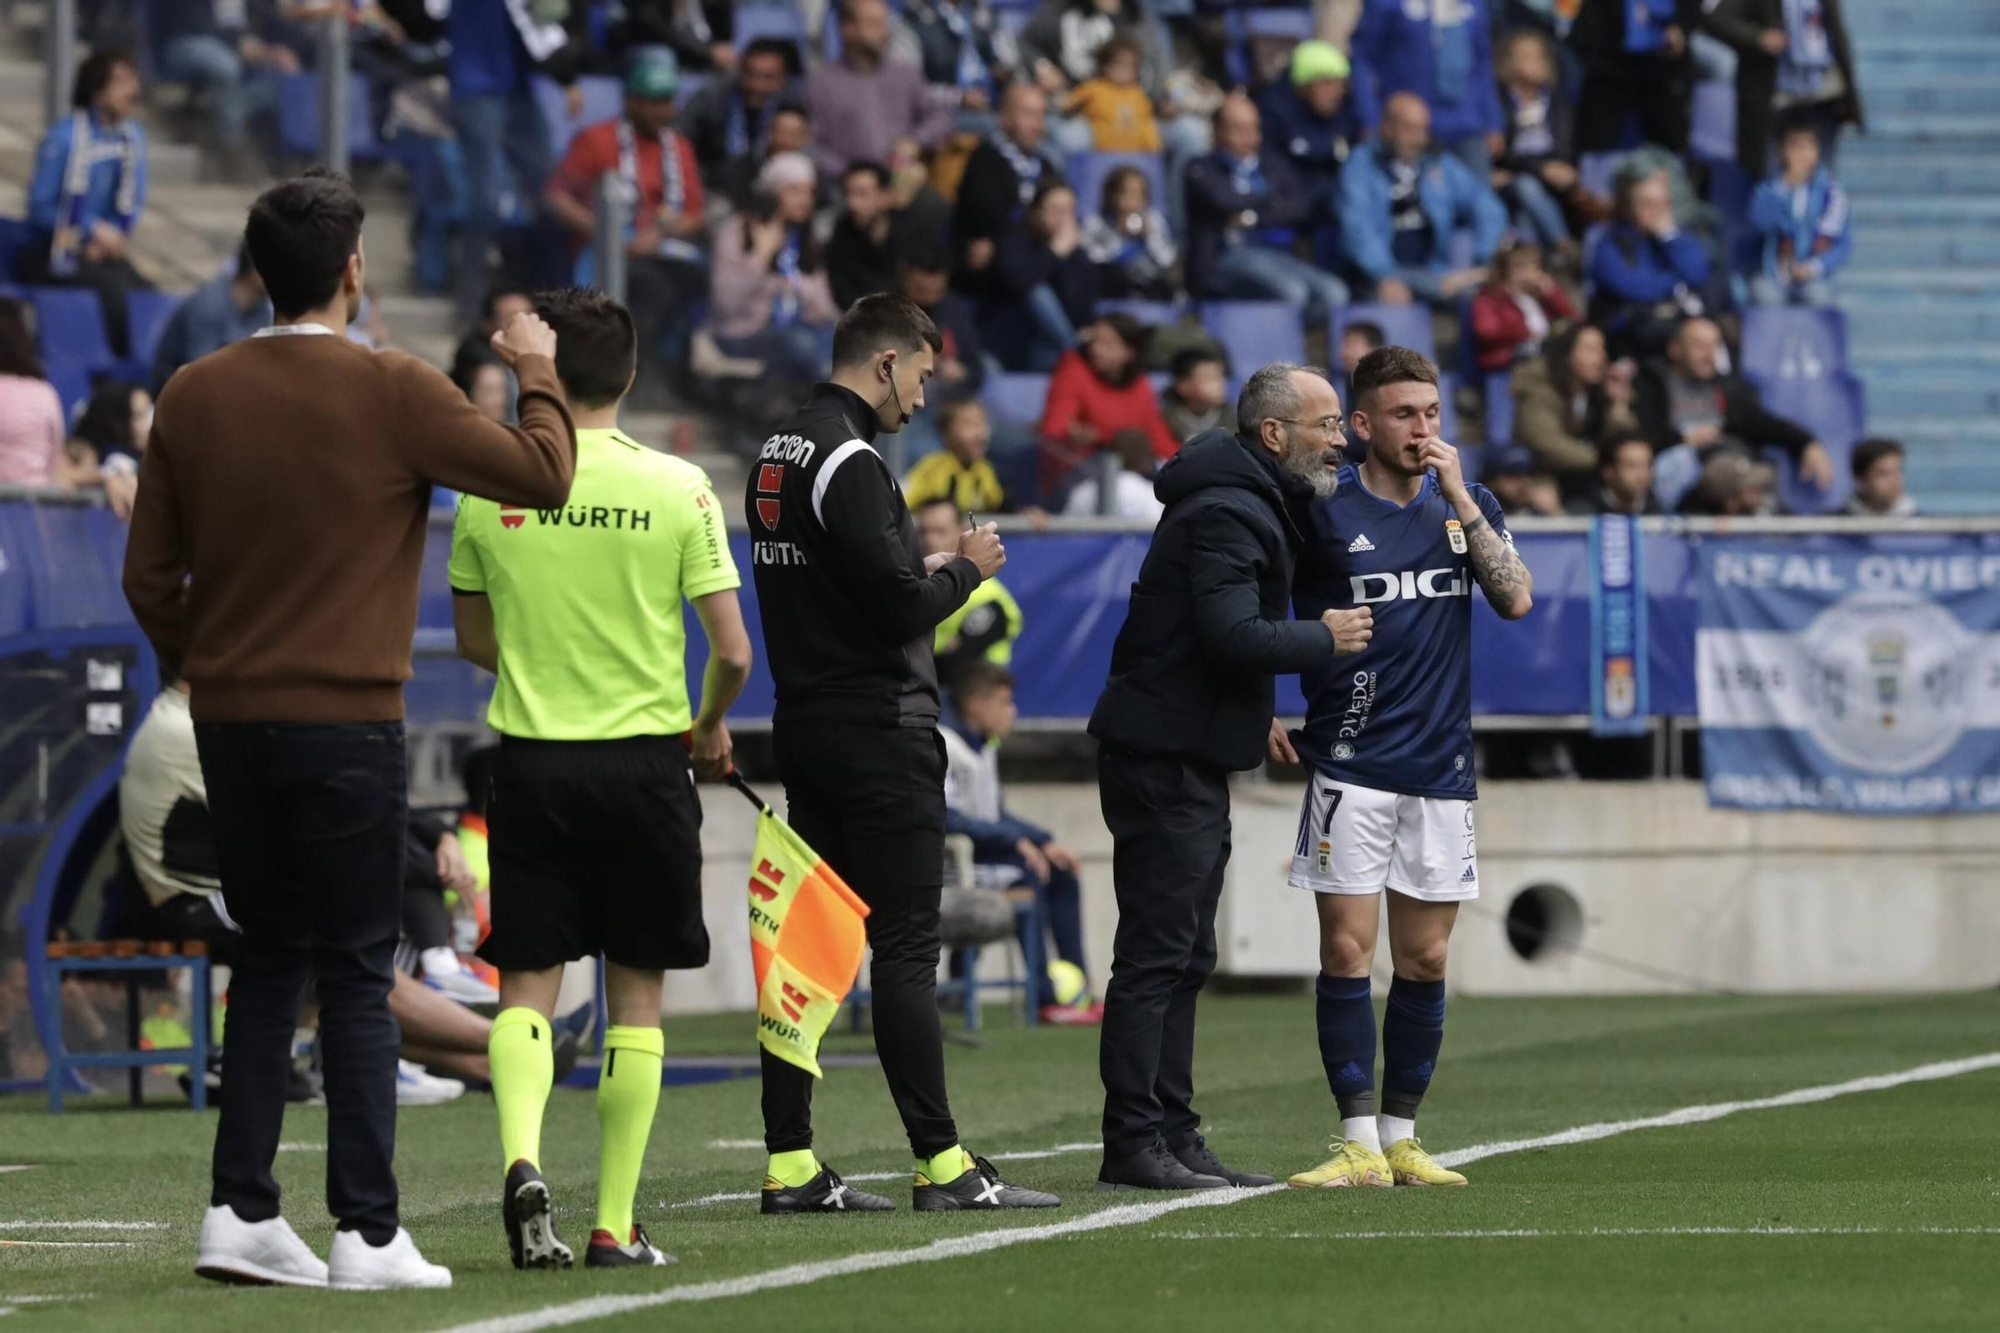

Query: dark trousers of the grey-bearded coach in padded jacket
left=1098, top=749, right=1230, bottom=1155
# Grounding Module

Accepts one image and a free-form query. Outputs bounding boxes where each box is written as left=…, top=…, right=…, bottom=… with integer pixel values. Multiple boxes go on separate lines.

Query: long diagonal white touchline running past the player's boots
left=422, top=1051, right=2000, bottom=1333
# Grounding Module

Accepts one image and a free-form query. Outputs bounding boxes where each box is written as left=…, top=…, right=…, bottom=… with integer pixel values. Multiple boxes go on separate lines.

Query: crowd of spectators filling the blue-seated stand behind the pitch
left=0, top=0, right=1908, bottom=516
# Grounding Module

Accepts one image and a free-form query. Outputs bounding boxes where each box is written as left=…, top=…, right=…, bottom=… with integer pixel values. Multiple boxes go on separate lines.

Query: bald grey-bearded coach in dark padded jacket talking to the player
left=1090, top=362, right=1372, bottom=1189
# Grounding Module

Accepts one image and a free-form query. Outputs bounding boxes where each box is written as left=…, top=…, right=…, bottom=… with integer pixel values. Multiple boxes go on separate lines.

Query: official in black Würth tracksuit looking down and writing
left=744, top=294, right=1058, bottom=1213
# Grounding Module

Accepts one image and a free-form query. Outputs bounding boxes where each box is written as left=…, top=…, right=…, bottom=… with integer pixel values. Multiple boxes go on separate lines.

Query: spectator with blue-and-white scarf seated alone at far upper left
left=16, top=50, right=152, bottom=356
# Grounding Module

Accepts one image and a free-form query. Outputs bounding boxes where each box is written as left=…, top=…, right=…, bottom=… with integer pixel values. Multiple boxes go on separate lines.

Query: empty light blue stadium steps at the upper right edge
left=1838, top=0, right=2000, bottom=514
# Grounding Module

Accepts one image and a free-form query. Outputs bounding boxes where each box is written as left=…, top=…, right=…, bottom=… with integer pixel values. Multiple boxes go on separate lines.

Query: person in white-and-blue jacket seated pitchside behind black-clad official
left=938, top=660, right=1104, bottom=1025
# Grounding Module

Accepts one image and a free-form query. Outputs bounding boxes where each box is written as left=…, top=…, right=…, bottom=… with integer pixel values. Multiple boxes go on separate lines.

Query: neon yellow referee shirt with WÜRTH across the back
left=450, top=430, right=742, bottom=741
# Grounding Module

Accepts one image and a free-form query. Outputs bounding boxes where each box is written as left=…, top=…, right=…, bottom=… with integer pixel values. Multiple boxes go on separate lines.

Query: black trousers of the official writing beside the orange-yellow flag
left=762, top=723, right=958, bottom=1157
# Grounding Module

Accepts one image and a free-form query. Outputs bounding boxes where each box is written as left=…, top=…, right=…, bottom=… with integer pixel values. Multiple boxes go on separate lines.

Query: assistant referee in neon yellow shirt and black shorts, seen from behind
left=450, top=288, right=750, bottom=1269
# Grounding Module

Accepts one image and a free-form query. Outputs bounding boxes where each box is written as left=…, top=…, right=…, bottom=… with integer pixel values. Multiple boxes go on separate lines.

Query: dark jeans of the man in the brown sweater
left=194, top=723, right=408, bottom=1245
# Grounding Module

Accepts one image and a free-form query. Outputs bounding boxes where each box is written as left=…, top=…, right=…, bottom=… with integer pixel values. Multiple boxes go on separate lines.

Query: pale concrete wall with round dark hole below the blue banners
left=628, top=781, right=2000, bottom=1013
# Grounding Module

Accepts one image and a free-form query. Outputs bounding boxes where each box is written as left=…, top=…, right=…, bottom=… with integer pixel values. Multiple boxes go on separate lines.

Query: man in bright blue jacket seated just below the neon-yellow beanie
left=1340, top=92, right=1506, bottom=306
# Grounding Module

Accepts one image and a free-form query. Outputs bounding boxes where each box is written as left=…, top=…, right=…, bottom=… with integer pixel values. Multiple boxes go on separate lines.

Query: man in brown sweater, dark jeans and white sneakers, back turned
left=124, top=172, right=576, bottom=1287
